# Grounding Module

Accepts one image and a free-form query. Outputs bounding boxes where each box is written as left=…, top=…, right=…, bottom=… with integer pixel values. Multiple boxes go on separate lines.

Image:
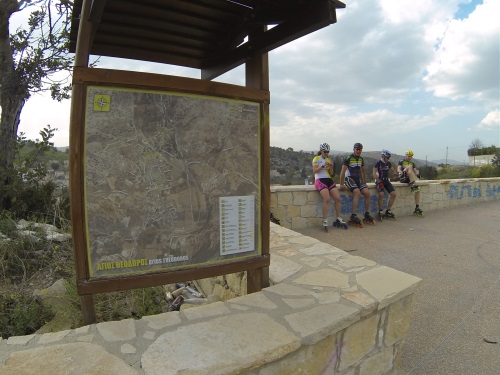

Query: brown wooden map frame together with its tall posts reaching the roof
left=70, top=0, right=271, bottom=324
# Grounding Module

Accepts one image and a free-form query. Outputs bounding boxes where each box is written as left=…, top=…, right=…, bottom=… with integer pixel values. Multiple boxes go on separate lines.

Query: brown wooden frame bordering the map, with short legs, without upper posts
left=70, top=67, right=270, bottom=321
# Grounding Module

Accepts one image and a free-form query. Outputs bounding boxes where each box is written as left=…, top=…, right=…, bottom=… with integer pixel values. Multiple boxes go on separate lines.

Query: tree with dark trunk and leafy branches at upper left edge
left=0, top=0, right=73, bottom=211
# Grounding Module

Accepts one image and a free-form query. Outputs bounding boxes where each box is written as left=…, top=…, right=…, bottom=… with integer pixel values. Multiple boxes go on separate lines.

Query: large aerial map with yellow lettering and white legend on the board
left=85, top=86, right=260, bottom=277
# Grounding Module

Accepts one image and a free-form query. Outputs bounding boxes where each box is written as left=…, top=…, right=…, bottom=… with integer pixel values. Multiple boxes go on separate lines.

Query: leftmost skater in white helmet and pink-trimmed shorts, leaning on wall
left=312, top=143, right=347, bottom=229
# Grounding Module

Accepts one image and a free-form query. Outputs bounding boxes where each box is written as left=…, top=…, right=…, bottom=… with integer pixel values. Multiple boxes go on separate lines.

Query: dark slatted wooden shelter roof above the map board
left=70, top=0, right=345, bottom=79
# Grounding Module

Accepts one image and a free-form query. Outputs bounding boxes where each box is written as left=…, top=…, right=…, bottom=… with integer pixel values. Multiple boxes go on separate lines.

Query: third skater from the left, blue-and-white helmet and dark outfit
left=373, top=150, right=397, bottom=220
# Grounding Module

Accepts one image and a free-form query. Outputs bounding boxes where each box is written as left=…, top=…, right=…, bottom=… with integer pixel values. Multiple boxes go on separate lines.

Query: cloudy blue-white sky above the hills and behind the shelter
left=11, top=0, right=500, bottom=163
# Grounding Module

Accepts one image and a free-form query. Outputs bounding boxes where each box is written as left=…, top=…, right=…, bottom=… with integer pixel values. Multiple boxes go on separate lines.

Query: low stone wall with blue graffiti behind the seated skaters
left=271, top=177, right=500, bottom=230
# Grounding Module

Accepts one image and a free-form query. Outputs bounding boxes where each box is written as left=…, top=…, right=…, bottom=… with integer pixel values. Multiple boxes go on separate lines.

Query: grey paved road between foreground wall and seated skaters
left=301, top=201, right=500, bottom=375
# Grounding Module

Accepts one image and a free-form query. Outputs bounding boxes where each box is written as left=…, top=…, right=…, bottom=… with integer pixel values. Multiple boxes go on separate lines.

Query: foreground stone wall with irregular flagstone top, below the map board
left=0, top=223, right=420, bottom=375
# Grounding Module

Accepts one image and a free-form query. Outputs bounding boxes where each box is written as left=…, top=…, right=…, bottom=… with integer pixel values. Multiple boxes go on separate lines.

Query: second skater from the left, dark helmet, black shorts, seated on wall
left=340, top=143, right=373, bottom=226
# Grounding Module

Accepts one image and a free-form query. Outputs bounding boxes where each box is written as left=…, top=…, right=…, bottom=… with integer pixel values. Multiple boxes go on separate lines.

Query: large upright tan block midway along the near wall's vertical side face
left=339, top=313, right=380, bottom=371
